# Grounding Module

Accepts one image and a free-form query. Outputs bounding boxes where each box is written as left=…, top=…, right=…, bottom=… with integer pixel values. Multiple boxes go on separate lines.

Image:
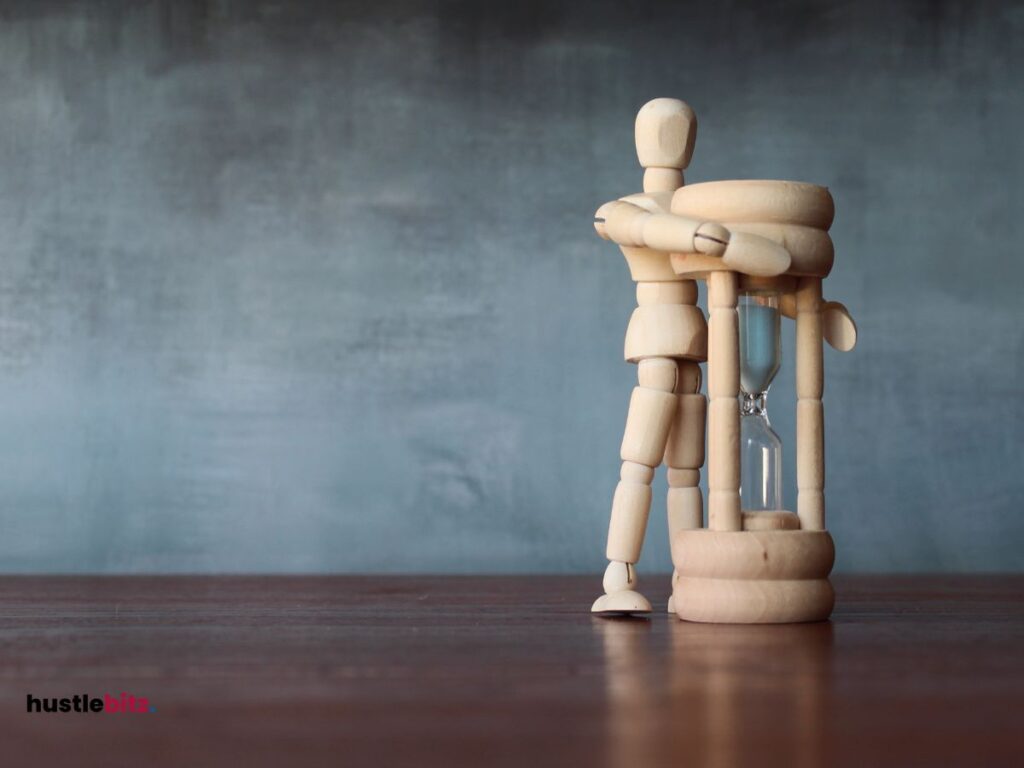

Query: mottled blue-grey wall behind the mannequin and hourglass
left=0, top=0, right=1024, bottom=571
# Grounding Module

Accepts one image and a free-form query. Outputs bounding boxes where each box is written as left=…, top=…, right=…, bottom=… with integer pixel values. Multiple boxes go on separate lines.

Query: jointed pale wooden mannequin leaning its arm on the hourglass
left=592, top=98, right=790, bottom=613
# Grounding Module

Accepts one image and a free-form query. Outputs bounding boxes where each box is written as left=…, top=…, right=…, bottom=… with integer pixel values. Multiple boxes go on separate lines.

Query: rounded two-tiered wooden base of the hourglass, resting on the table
left=672, top=528, right=836, bottom=624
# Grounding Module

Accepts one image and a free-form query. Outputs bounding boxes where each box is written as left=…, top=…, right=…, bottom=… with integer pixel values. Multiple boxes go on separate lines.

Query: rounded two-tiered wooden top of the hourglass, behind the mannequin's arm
left=672, top=179, right=836, bottom=278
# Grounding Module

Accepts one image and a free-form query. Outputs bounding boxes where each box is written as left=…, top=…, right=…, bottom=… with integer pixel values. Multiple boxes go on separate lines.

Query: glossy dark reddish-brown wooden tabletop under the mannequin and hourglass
left=0, top=575, right=1024, bottom=768
